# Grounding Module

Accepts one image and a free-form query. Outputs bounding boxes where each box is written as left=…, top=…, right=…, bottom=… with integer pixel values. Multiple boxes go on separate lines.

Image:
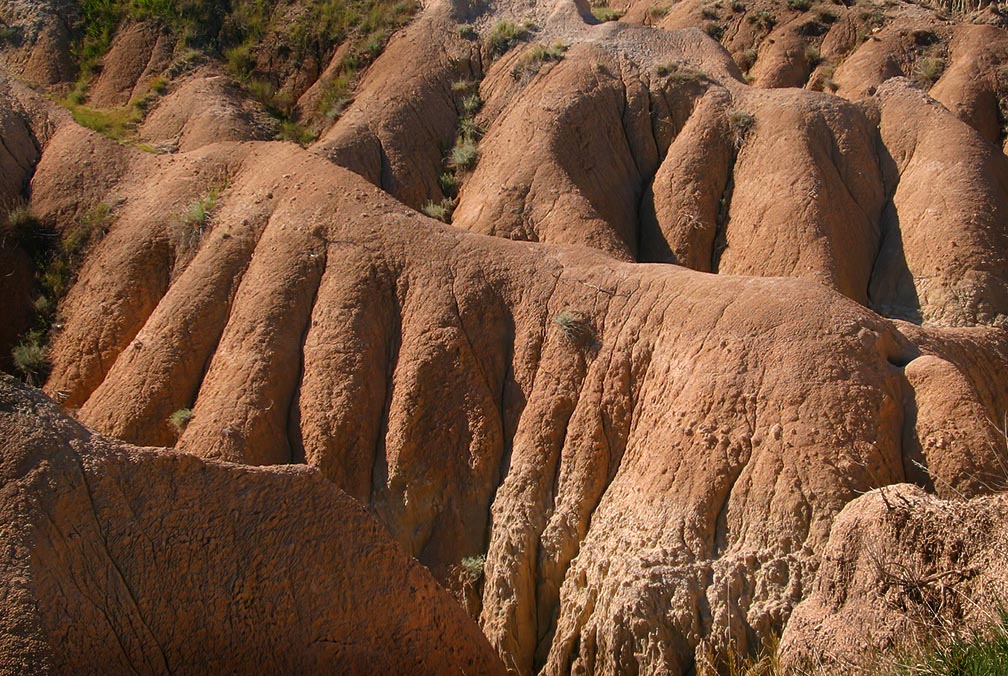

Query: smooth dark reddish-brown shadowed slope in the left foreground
left=0, top=376, right=503, bottom=675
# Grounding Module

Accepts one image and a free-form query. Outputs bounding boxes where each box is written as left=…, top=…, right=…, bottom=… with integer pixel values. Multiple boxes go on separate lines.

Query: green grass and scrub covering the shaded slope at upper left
left=67, top=0, right=418, bottom=136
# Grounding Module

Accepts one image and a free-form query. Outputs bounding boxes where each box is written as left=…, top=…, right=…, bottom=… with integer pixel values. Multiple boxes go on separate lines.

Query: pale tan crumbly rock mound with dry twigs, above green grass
left=780, top=486, right=1008, bottom=669
